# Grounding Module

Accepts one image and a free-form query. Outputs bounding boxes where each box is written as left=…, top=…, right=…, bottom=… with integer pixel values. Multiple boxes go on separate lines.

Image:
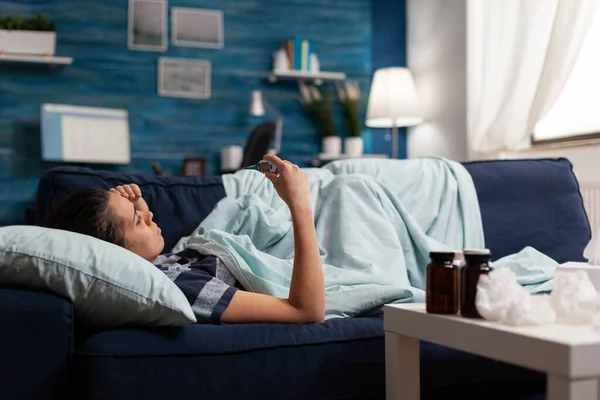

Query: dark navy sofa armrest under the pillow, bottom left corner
left=0, top=287, right=74, bottom=400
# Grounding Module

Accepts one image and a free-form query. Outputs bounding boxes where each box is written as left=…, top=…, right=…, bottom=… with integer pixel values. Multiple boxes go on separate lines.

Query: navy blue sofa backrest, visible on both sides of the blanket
left=36, top=159, right=591, bottom=262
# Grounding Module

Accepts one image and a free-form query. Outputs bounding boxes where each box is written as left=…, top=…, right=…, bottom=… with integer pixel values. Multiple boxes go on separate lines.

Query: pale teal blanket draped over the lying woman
left=174, top=157, right=557, bottom=318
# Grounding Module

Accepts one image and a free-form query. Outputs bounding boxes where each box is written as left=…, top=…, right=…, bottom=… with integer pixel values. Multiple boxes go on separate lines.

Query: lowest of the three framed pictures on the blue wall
left=158, top=57, right=211, bottom=99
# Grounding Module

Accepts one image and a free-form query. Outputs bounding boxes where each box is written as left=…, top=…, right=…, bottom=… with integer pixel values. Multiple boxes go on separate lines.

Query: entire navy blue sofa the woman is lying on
left=0, top=159, right=590, bottom=400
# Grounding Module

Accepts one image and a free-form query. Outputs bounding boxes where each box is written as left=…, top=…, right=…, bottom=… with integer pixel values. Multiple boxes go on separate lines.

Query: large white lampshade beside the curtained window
left=366, top=67, right=423, bottom=128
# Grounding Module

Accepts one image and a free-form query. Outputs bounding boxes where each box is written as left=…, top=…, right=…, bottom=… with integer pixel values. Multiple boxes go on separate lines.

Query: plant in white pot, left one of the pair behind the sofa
left=299, top=82, right=342, bottom=155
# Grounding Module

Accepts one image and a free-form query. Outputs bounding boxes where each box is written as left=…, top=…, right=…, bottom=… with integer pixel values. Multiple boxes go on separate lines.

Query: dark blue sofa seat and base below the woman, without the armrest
left=74, top=318, right=539, bottom=400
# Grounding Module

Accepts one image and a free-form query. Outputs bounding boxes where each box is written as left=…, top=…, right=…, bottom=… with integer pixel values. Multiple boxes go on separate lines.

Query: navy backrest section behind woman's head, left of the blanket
left=35, top=166, right=225, bottom=251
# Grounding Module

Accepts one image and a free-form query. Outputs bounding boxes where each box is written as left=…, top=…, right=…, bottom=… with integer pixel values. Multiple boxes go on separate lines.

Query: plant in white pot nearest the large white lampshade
left=337, top=82, right=364, bottom=157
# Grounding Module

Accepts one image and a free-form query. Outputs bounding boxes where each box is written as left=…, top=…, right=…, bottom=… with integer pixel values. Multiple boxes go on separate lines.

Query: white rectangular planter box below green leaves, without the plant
left=0, top=29, right=56, bottom=56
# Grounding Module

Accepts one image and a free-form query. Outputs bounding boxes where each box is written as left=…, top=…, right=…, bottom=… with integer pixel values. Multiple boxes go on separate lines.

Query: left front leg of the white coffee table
left=385, top=332, right=420, bottom=400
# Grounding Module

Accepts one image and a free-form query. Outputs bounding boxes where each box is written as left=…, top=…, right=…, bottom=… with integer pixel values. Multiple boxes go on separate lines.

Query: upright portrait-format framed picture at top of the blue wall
left=127, top=0, right=168, bottom=51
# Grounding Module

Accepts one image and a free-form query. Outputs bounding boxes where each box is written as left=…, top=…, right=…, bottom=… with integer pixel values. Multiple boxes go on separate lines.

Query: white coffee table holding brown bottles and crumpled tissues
left=384, top=303, right=600, bottom=400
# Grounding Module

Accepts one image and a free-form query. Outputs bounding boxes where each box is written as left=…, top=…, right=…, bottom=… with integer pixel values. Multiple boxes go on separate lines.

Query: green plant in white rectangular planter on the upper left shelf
left=0, top=15, right=56, bottom=56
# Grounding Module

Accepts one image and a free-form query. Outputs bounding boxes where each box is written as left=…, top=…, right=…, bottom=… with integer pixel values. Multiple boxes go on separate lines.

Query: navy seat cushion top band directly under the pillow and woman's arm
left=76, top=318, right=382, bottom=357
